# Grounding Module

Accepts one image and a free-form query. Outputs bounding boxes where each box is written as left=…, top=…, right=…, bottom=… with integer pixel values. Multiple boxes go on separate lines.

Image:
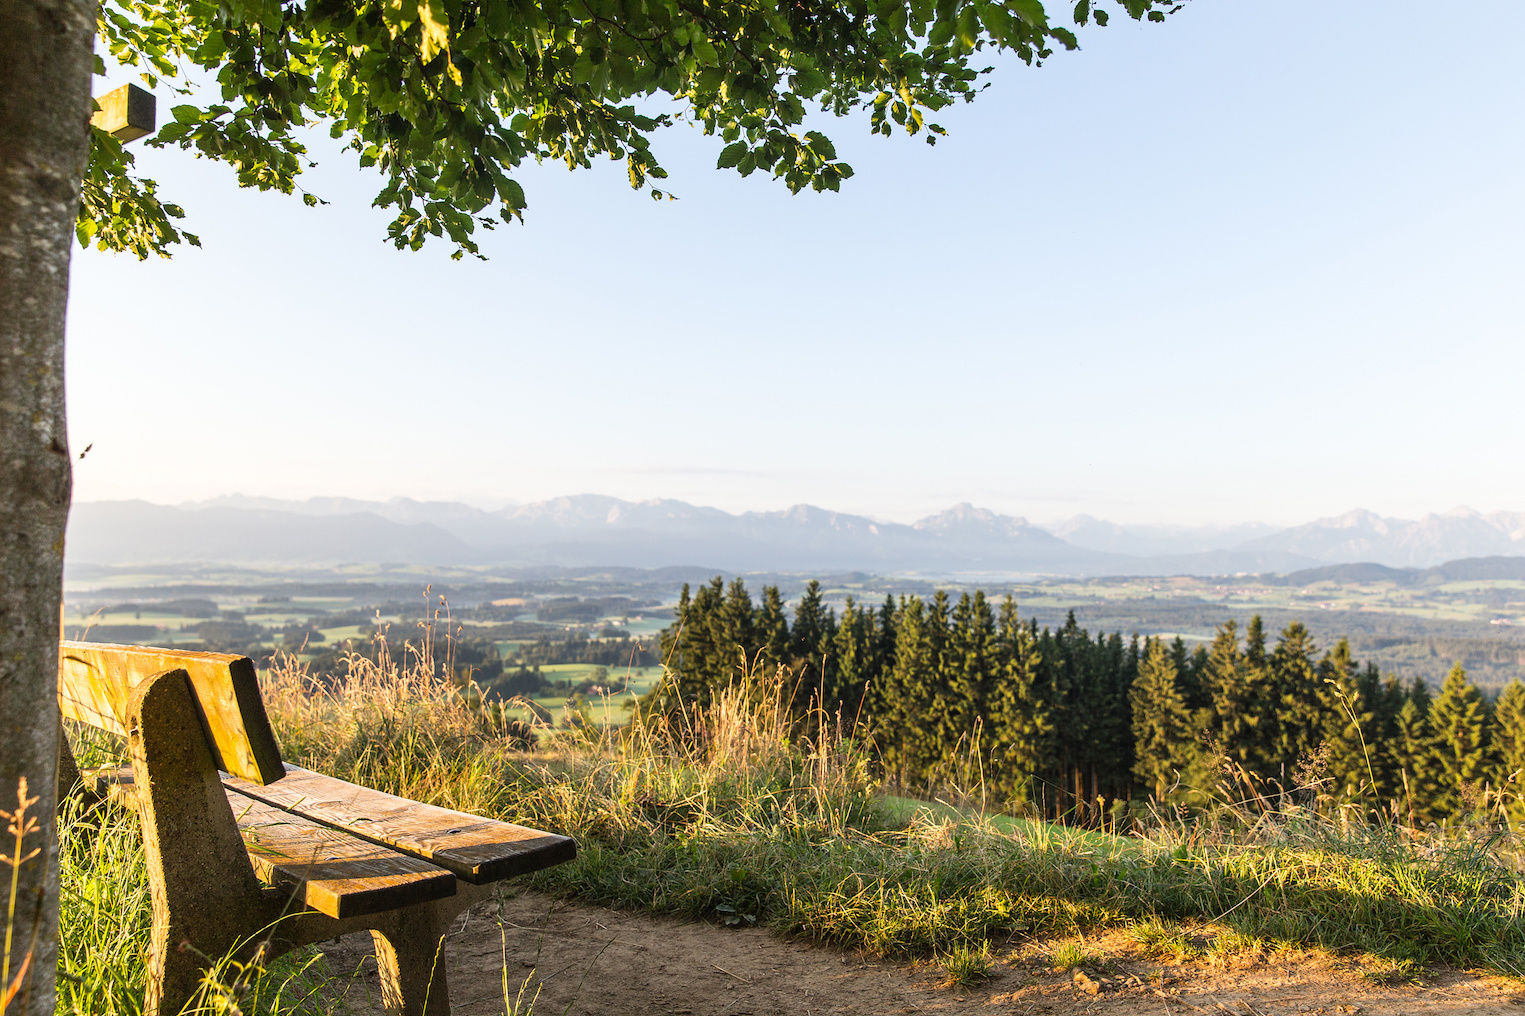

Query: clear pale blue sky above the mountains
left=69, top=0, right=1525, bottom=523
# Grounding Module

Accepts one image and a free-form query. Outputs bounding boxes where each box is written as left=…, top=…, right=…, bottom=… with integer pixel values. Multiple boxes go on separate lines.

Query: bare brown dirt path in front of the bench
left=318, top=892, right=1525, bottom=1016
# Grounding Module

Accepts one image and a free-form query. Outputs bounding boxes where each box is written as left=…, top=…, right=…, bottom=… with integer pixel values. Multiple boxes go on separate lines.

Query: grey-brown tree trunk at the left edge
left=0, top=0, right=95, bottom=1016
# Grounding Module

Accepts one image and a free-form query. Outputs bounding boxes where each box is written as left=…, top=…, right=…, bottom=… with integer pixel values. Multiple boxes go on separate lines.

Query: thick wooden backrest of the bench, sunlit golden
left=58, top=642, right=285, bottom=784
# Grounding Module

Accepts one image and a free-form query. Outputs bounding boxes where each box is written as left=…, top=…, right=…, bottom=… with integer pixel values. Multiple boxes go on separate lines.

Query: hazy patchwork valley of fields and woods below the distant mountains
left=66, top=566, right=1525, bottom=691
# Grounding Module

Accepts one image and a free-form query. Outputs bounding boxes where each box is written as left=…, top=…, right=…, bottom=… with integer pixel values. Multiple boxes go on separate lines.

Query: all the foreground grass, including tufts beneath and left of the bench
left=47, top=634, right=1525, bottom=1016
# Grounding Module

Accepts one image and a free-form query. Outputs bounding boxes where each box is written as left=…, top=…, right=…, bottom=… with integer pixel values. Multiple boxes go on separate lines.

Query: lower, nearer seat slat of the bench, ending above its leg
left=90, top=769, right=456, bottom=918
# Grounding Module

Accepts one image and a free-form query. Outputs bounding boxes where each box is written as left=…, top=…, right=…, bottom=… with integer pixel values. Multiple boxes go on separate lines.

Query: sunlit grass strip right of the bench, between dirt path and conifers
left=256, top=649, right=1525, bottom=973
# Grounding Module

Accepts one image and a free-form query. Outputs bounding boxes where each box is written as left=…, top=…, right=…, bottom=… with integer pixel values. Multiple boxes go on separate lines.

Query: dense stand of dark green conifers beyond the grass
left=647, top=577, right=1525, bottom=824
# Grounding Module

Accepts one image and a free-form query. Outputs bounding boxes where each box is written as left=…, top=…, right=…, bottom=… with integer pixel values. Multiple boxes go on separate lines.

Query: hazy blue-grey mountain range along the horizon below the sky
left=69, top=494, right=1525, bottom=575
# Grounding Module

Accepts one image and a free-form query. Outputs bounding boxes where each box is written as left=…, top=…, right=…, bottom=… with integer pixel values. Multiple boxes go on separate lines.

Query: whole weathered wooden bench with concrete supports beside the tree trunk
left=58, top=642, right=576, bottom=1016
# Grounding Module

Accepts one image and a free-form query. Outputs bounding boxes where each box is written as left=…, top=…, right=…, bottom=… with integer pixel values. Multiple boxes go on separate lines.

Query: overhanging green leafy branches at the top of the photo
left=78, top=0, right=1179, bottom=258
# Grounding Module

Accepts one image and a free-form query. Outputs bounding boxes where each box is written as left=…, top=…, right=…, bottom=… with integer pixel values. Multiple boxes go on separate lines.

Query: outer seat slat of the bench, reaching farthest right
left=223, top=766, right=576, bottom=885
